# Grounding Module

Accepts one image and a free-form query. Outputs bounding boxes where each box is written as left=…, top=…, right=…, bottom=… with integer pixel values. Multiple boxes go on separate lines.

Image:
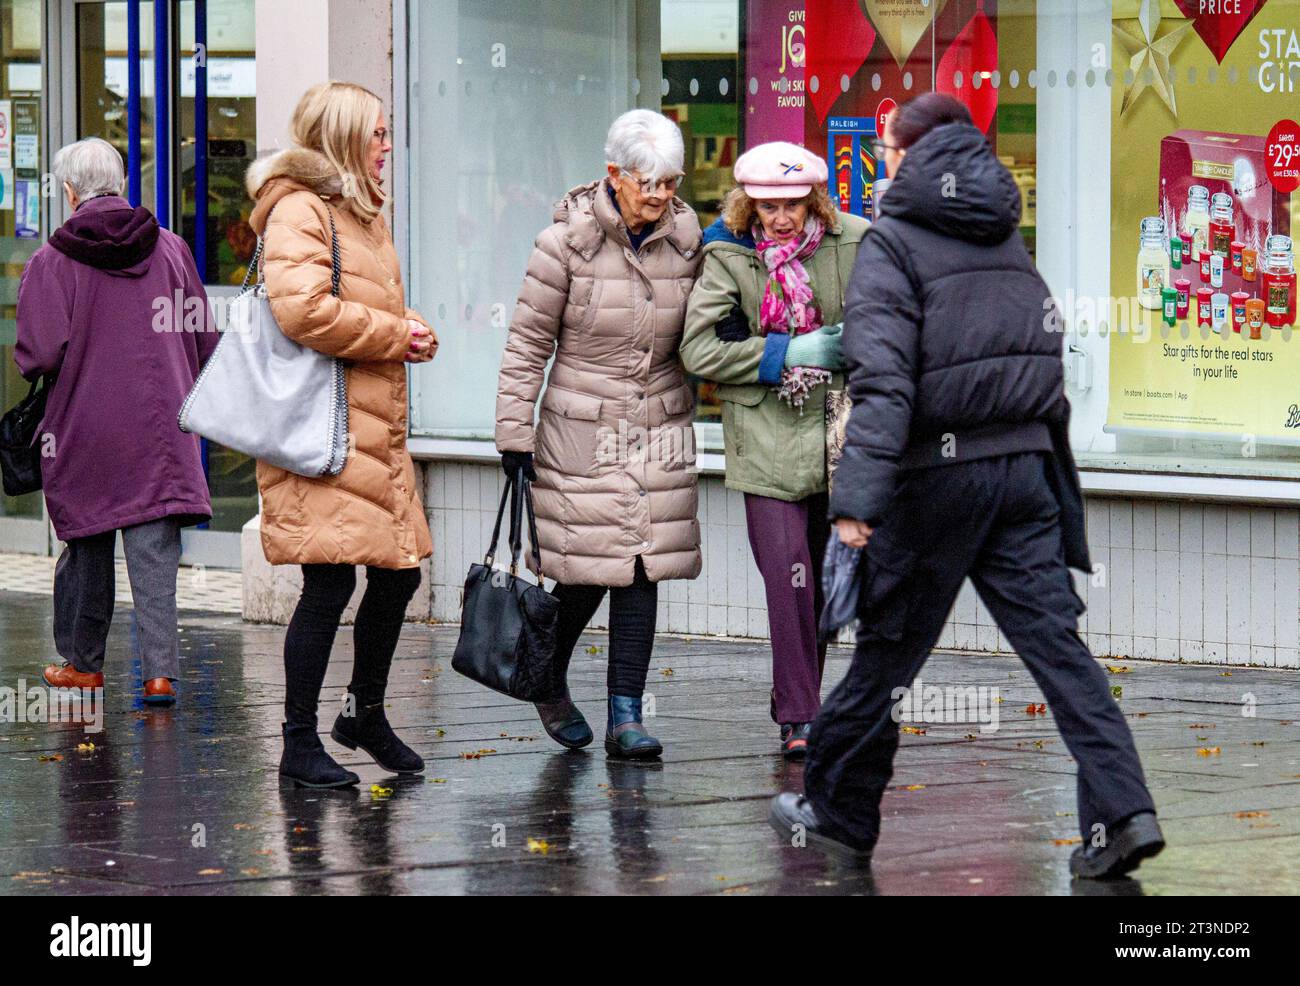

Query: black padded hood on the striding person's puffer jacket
left=880, top=124, right=1021, bottom=245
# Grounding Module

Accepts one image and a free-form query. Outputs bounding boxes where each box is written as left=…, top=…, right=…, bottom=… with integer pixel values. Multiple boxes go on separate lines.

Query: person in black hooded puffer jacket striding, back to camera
left=771, top=94, right=1164, bottom=877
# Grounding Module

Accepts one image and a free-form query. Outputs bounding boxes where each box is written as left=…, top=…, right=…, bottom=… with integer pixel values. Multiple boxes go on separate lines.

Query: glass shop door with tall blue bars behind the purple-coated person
left=60, top=0, right=257, bottom=568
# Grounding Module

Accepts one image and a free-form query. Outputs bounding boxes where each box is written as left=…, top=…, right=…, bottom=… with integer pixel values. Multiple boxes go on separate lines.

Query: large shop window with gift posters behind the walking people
left=411, top=0, right=1300, bottom=490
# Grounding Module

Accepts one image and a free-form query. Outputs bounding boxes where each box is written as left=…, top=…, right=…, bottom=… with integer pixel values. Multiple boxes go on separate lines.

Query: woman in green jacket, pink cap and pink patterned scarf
left=681, top=142, right=867, bottom=758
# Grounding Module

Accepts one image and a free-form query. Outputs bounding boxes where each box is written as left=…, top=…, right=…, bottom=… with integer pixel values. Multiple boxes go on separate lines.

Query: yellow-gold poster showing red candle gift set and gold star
left=1106, top=0, right=1300, bottom=444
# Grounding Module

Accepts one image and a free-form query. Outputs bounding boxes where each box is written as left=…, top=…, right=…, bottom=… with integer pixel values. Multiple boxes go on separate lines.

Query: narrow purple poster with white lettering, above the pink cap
left=744, top=0, right=806, bottom=151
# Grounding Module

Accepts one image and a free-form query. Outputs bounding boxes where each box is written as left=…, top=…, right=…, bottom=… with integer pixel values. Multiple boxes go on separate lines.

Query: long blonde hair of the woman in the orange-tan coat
left=290, top=82, right=387, bottom=220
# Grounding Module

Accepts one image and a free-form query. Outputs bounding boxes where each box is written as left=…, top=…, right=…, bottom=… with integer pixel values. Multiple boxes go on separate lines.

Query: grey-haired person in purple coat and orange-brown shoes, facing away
left=14, top=138, right=218, bottom=704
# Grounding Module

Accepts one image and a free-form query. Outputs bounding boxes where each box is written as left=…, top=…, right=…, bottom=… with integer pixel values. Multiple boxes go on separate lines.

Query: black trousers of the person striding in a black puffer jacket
left=805, top=453, right=1153, bottom=848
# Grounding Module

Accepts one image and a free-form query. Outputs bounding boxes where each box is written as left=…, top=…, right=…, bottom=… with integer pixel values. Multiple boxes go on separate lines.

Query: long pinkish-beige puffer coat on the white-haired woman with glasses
left=497, top=180, right=701, bottom=585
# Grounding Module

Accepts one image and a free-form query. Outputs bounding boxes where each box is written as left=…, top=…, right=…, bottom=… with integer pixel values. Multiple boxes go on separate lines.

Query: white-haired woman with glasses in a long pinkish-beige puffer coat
left=497, top=109, right=701, bottom=758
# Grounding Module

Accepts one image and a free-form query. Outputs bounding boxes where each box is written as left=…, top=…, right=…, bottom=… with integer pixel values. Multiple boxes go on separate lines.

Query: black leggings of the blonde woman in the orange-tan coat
left=285, top=565, right=420, bottom=728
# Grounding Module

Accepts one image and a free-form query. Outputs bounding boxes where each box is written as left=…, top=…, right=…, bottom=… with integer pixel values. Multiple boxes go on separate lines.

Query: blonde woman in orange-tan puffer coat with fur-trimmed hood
left=247, top=82, right=438, bottom=787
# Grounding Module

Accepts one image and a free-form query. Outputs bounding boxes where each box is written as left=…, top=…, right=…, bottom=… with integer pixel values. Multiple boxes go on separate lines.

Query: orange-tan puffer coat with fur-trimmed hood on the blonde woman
left=247, top=148, right=437, bottom=568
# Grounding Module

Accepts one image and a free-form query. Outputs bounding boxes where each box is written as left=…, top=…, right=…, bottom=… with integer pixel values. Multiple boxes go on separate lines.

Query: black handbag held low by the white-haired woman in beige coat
left=451, top=470, right=560, bottom=702
